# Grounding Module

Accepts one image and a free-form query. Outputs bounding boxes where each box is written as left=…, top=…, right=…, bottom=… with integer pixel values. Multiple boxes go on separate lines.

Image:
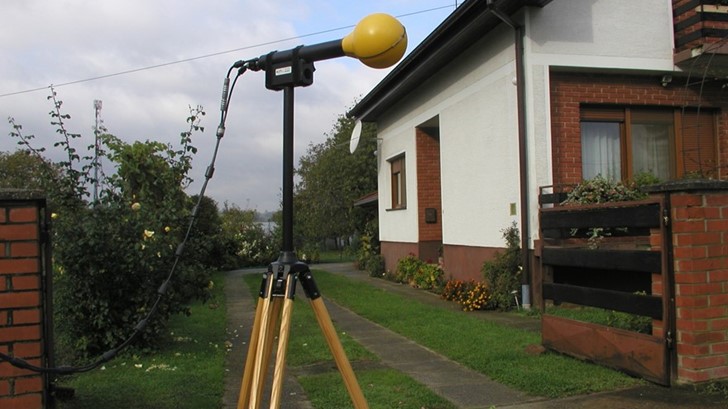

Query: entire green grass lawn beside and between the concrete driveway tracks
left=58, top=271, right=640, bottom=409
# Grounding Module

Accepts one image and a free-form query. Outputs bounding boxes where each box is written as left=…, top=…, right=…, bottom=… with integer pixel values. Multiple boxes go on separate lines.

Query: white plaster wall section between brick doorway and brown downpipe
left=440, top=71, right=519, bottom=247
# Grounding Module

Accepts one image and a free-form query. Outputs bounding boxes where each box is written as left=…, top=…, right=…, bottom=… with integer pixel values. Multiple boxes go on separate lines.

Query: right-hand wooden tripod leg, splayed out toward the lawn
left=299, top=271, right=369, bottom=409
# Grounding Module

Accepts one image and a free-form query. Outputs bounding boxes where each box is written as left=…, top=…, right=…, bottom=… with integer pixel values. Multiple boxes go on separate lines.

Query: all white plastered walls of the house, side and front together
left=378, top=0, right=674, bottom=247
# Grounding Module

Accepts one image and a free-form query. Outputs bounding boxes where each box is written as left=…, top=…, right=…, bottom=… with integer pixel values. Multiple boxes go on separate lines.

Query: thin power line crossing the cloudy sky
left=0, top=4, right=453, bottom=98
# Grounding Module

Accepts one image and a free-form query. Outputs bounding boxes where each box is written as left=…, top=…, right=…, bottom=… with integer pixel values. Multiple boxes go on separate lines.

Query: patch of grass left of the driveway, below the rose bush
left=58, top=274, right=225, bottom=409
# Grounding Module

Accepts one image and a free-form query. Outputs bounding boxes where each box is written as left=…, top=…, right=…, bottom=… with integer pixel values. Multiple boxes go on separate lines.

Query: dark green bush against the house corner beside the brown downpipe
left=481, top=222, right=522, bottom=311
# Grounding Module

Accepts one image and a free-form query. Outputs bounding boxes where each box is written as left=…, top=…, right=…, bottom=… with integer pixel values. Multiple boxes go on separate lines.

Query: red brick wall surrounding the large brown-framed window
left=550, top=72, right=728, bottom=185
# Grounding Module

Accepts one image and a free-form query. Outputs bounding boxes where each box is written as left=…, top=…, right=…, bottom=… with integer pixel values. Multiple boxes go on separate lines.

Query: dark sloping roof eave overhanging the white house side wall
left=347, top=0, right=551, bottom=122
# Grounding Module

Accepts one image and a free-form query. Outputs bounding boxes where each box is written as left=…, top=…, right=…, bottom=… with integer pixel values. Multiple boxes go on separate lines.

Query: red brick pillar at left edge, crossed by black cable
left=0, top=190, right=47, bottom=409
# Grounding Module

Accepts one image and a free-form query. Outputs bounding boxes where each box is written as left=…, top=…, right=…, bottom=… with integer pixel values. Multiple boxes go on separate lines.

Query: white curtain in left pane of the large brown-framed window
left=581, top=122, right=622, bottom=180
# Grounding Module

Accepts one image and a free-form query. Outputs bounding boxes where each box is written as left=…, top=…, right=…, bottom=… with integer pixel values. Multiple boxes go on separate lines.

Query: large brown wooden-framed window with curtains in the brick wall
left=581, top=107, right=716, bottom=180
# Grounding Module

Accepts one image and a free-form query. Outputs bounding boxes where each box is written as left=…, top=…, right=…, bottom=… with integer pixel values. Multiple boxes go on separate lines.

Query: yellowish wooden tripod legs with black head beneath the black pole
left=238, top=262, right=369, bottom=409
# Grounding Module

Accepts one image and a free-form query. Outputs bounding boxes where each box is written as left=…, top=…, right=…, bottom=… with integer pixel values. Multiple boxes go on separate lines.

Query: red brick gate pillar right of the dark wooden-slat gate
left=670, top=182, right=728, bottom=383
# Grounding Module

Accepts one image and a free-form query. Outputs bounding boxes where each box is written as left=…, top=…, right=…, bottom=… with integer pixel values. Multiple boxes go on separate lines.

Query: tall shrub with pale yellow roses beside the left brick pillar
left=11, top=92, right=210, bottom=356
